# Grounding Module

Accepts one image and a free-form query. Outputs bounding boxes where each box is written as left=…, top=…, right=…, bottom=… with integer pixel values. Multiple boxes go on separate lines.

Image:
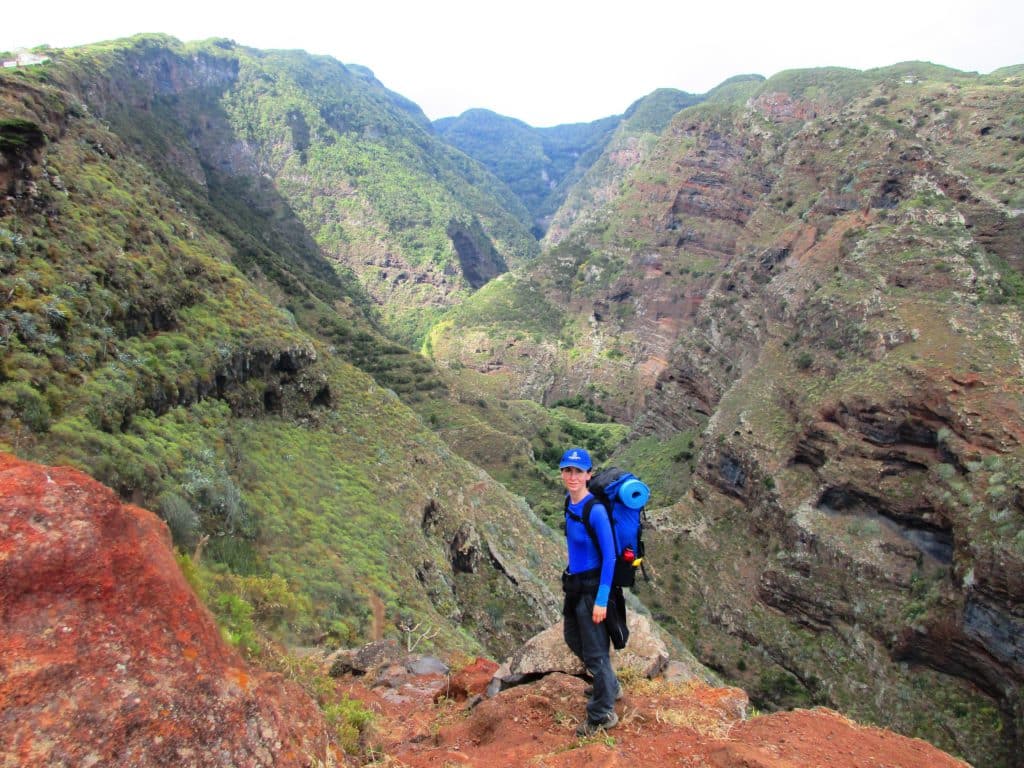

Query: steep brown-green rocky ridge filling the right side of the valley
left=431, top=62, right=1024, bottom=766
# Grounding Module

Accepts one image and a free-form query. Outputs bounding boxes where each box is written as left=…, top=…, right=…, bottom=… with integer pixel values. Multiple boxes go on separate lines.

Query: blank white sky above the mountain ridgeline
left=0, top=0, right=1024, bottom=126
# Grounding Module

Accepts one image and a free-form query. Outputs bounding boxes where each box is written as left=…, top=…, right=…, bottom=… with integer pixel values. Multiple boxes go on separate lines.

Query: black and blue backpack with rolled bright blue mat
left=565, top=467, right=650, bottom=587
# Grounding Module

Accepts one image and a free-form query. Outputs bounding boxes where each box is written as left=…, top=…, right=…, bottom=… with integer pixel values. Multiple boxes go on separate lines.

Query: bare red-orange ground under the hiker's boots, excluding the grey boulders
left=333, top=660, right=968, bottom=768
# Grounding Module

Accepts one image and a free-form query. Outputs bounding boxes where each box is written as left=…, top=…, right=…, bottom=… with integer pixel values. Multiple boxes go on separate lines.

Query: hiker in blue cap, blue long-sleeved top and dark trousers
left=558, top=447, right=622, bottom=736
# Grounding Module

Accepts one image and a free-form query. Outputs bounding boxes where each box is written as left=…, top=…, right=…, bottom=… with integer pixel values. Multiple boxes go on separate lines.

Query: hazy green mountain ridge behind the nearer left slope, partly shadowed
left=49, top=36, right=537, bottom=340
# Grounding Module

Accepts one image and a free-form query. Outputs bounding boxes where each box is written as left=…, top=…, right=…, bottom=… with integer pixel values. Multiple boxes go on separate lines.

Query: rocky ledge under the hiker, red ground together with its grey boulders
left=311, top=630, right=968, bottom=768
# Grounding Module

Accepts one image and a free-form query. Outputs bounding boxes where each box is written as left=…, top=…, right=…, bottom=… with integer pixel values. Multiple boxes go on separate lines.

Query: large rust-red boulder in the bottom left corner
left=0, top=455, right=328, bottom=768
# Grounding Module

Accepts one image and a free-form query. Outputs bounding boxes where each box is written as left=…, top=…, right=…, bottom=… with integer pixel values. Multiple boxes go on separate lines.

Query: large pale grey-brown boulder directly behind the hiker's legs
left=487, top=611, right=669, bottom=696
